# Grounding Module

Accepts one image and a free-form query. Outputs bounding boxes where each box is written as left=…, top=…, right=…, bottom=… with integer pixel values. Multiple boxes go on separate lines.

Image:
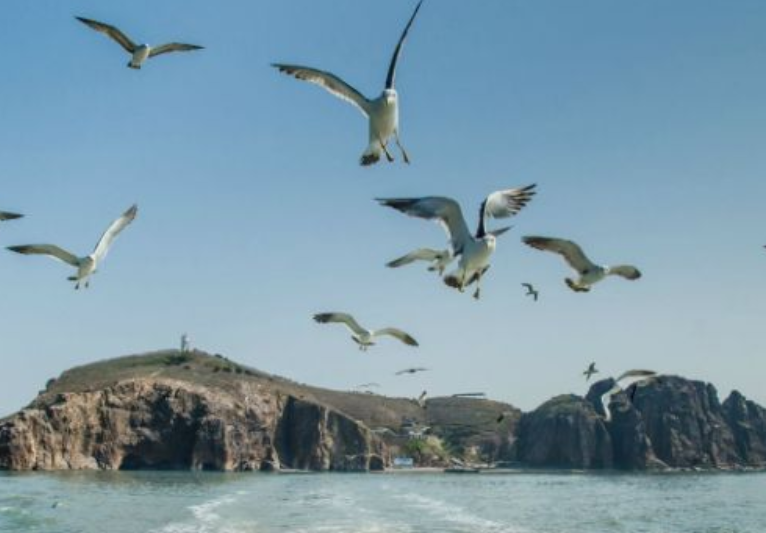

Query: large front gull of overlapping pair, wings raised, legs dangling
left=376, top=184, right=536, bottom=300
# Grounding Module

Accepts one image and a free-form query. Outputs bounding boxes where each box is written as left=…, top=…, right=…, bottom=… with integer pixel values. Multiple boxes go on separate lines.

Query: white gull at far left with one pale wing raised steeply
left=8, top=205, right=138, bottom=289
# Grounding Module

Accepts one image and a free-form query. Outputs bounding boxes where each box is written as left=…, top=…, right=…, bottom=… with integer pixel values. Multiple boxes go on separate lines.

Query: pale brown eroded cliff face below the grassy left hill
left=0, top=379, right=387, bottom=471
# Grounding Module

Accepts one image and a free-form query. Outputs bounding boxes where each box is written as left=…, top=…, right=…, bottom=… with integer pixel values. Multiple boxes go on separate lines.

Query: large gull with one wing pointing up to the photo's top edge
left=272, top=0, right=423, bottom=166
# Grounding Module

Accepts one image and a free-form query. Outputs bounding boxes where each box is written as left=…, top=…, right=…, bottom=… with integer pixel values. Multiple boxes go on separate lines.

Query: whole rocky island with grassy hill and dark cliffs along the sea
left=0, top=350, right=766, bottom=471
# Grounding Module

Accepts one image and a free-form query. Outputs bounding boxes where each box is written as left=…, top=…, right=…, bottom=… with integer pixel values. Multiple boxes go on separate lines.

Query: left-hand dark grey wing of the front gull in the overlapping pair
left=377, top=196, right=472, bottom=255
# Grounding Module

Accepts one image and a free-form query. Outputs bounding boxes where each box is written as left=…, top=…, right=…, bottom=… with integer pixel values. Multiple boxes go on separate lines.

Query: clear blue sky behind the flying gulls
left=0, top=0, right=766, bottom=415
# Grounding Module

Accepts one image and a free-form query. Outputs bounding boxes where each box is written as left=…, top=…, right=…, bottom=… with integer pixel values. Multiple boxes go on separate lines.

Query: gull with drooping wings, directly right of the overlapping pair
left=522, top=236, right=641, bottom=292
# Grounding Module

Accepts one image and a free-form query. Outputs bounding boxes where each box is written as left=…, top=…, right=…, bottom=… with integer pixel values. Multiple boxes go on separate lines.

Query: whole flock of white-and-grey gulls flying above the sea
left=0, top=0, right=657, bottom=420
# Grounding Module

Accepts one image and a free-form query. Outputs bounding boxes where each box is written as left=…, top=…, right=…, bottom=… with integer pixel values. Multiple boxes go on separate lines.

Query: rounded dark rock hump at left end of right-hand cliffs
left=515, top=394, right=613, bottom=468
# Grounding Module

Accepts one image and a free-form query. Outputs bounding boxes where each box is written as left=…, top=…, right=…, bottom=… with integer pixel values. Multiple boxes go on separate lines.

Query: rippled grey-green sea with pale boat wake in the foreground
left=0, top=472, right=766, bottom=533
